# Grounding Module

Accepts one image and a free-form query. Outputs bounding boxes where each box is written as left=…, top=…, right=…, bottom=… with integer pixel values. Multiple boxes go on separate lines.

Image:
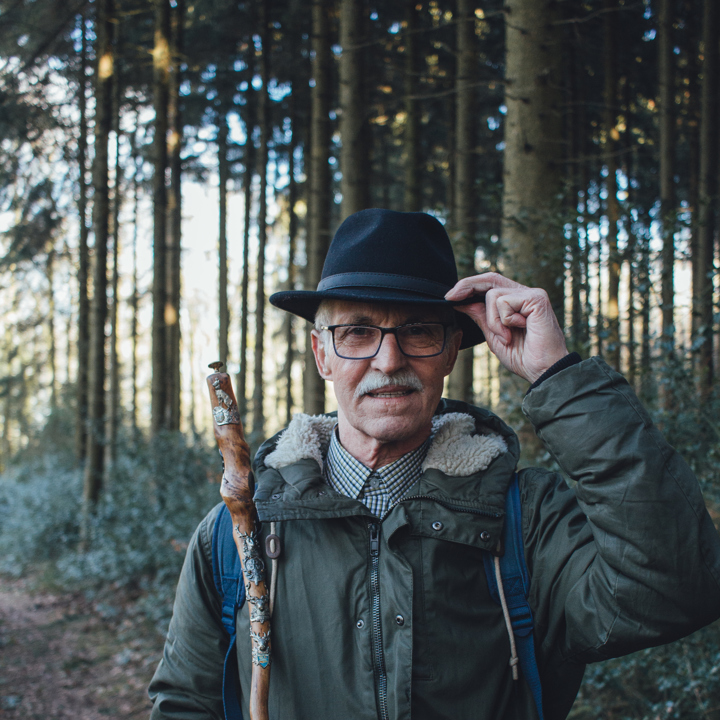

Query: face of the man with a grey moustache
left=313, top=301, right=462, bottom=449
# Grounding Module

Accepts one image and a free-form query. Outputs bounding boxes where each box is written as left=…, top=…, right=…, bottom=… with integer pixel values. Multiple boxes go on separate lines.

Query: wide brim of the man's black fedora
left=270, top=287, right=485, bottom=350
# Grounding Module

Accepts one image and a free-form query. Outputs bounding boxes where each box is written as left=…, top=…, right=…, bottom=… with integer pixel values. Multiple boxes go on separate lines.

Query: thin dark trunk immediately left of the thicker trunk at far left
left=75, top=15, right=90, bottom=462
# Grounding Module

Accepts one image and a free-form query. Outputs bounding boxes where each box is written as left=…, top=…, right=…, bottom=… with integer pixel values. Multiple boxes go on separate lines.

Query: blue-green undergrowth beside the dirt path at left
left=0, top=434, right=220, bottom=620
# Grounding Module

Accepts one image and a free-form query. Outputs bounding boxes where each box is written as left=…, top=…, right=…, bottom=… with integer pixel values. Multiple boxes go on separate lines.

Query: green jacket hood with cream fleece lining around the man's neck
left=254, top=400, right=520, bottom=520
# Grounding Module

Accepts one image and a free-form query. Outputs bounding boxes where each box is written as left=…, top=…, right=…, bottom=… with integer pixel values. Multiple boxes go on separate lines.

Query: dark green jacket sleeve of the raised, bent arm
left=521, top=358, right=720, bottom=663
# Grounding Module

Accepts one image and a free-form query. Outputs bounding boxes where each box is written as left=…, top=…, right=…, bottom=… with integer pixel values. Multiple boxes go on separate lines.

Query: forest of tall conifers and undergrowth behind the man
left=0, top=0, right=720, bottom=720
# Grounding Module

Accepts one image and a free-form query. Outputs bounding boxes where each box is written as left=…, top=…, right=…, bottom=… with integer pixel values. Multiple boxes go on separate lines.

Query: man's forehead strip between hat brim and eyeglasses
left=318, top=300, right=453, bottom=327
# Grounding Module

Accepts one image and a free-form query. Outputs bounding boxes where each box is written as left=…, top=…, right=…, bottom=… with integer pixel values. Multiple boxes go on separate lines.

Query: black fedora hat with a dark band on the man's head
left=270, top=209, right=485, bottom=348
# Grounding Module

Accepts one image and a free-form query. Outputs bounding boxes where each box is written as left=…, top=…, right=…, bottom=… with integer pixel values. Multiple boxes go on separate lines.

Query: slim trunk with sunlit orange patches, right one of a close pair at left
left=165, top=0, right=185, bottom=431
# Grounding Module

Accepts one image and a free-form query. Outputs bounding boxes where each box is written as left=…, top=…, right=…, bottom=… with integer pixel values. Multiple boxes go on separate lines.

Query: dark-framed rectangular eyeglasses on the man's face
left=320, top=323, right=449, bottom=360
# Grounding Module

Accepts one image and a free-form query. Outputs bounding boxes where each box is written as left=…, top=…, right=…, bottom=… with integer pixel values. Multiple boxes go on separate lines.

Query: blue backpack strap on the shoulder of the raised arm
left=483, top=473, right=543, bottom=720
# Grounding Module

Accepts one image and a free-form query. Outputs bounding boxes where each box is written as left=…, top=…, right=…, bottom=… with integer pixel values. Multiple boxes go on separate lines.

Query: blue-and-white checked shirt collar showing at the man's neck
left=325, top=426, right=430, bottom=518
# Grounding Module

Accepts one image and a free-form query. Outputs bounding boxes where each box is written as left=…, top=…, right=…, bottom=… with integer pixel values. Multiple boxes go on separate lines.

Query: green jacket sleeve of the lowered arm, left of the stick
left=148, top=506, right=228, bottom=720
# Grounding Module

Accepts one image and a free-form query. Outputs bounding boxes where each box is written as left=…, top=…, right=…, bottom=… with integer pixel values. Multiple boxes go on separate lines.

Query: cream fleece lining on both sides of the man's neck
left=265, top=413, right=508, bottom=477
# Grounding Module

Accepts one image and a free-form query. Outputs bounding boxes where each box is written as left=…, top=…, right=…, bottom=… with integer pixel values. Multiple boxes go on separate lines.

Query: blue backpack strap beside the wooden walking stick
left=212, top=505, right=245, bottom=720
